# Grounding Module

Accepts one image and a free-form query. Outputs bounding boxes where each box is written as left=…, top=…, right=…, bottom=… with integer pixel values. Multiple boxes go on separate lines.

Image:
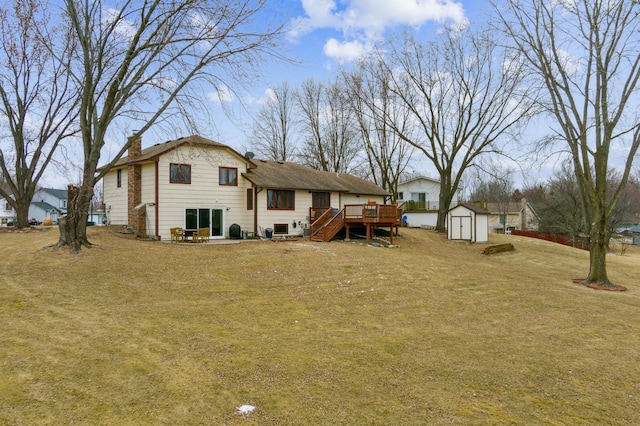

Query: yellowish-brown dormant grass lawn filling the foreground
left=0, top=227, right=640, bottom=425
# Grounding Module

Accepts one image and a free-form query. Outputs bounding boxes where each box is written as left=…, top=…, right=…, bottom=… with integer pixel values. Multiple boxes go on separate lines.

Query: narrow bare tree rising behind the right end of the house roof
left=343, top=58, right=415, bottom=201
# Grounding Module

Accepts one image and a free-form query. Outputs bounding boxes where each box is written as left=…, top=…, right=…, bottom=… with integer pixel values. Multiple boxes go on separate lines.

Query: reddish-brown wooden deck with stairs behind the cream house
left=309, top=203, right=402, bottom=244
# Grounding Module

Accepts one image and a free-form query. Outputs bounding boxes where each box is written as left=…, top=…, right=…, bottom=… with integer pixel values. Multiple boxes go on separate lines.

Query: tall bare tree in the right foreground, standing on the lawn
left=496, top=0, right=640, bottom=288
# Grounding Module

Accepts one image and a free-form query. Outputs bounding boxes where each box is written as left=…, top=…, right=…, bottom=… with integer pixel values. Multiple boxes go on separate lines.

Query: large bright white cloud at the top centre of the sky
left=290, top=0, right=467, bottom=60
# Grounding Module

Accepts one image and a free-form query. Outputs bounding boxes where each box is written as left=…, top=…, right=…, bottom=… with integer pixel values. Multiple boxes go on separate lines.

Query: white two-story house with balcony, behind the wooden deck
left=398, top=176, right=462, bottom=227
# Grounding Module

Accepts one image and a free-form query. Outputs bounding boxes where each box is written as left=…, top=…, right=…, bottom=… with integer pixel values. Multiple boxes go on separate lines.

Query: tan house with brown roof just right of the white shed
left=486, top=198, right=540, bottom=234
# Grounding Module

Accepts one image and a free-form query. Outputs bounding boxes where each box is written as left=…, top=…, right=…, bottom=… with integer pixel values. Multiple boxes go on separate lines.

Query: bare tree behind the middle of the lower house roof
left=297, top=79, right=360, bottom=173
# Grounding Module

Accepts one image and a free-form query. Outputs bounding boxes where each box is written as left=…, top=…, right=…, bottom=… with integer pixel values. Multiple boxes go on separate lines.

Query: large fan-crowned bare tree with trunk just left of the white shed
left=380, top=28, right=535, bottom=232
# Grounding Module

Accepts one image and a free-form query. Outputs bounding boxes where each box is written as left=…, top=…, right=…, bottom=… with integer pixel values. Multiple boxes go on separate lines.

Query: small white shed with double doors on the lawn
left=447, top=203, right=489, bottom=243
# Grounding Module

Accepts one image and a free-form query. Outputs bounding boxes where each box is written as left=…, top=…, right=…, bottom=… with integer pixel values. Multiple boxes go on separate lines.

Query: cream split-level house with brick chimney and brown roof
left=103, top=136, right=389, bottom=241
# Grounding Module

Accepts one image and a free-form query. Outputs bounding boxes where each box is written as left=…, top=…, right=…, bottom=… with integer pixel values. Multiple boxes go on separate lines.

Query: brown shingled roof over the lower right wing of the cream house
left=242, top=160, right=391, bottom=196
